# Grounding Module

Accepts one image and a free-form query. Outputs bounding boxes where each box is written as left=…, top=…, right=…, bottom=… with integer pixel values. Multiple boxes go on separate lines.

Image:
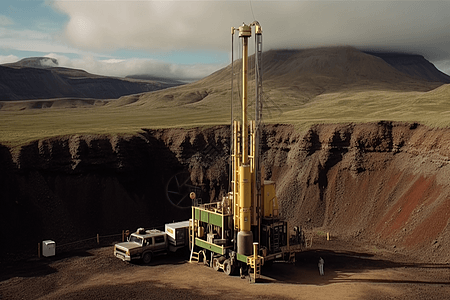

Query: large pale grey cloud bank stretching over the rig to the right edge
left=54, top=0, right=450, bottom=59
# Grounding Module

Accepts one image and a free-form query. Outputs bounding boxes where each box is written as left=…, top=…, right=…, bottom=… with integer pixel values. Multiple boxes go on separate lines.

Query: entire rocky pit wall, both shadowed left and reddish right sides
left=0, top=122, right=450, bottom=262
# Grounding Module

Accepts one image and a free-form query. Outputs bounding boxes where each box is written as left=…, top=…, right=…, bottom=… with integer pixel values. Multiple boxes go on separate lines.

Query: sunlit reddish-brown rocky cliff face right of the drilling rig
left=266, top=122, right=450, bottom=261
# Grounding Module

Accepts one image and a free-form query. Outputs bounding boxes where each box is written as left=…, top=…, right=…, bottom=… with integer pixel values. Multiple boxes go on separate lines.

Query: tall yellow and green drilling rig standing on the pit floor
left=189, top=21, right=304, bottom=282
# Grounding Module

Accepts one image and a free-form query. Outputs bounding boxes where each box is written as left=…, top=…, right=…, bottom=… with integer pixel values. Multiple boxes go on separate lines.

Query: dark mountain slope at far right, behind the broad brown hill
left=365, top=52, right=450, bottom=83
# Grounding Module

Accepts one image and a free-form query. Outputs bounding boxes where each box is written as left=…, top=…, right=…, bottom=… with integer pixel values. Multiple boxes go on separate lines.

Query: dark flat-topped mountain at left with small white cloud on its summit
left=0, top=57, right=180, bottom=101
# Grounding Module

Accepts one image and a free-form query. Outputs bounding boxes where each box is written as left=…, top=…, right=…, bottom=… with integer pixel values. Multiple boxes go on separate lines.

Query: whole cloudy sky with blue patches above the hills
left=0, top=0, right=450, bottom=80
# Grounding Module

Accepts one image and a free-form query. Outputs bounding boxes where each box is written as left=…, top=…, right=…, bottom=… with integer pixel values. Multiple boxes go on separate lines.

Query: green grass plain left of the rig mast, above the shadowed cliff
left=0, top=101, right=232, bottom=146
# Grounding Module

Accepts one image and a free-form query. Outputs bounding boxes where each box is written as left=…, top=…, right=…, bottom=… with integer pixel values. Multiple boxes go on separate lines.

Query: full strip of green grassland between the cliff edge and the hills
left=0, top=85, right=450, bottom=146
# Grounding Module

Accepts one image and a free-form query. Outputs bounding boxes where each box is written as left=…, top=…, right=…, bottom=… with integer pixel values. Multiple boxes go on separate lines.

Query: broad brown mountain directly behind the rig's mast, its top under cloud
left=131, top=47, right=443, bottom=106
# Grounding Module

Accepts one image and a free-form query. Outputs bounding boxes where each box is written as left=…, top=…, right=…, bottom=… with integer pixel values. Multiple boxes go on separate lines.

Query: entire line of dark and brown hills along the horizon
left=0, top=46, right=444, bottom=103
